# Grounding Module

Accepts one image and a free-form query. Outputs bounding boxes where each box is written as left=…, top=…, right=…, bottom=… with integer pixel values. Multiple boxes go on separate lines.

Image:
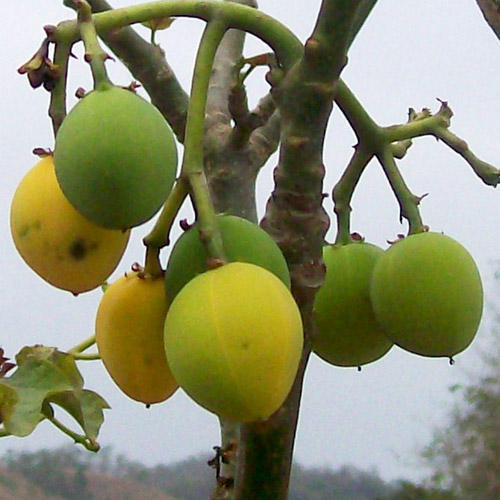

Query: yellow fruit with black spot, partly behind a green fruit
left=10, top=155, right=130, bottom=294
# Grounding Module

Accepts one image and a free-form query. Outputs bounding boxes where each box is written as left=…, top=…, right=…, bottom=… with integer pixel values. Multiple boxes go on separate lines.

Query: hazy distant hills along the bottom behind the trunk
left=0, top=447, right=426, bottom=500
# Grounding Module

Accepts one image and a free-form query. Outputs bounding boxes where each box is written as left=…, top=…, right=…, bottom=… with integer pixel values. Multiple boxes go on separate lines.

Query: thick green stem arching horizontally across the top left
left=54, top=0, right=302, bottom=68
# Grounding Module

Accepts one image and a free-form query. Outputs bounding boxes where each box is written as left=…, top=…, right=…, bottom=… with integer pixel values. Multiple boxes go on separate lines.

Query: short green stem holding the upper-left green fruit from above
left=75, top=0, right=112, bottom=89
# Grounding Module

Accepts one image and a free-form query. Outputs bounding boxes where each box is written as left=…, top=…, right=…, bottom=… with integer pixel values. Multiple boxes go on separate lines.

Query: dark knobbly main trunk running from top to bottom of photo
left=235, top=0, right=376, bottom=500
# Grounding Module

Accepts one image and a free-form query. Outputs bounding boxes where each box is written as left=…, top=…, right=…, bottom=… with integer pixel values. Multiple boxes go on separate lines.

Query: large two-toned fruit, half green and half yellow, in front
left=165, top=262, right=303, bottom=422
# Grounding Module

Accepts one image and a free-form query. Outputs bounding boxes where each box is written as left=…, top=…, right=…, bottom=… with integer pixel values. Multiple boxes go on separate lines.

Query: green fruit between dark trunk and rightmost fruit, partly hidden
left=313, top=242, right=393, bottom=366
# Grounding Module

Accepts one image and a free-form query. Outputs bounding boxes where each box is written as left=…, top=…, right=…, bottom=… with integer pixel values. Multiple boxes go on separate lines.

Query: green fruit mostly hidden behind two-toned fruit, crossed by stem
left=165, top=215, right=290, bottom=300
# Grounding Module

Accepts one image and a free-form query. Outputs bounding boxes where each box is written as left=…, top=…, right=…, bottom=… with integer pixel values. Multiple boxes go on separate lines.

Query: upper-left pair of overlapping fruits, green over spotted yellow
left=10, top=85, right=177, bottom=294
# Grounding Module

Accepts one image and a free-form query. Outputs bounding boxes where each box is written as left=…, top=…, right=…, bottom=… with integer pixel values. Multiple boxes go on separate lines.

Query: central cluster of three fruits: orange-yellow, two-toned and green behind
left=96, top=215, right=303, bottom=422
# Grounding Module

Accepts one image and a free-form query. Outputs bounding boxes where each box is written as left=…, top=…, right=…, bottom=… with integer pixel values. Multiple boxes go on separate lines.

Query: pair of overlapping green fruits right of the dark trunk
left=313, top=232, right=483, bottom=367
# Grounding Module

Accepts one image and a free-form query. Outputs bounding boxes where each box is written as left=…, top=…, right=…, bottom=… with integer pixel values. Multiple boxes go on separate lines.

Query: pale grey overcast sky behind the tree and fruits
left=0, top=0, right=500, bottom=479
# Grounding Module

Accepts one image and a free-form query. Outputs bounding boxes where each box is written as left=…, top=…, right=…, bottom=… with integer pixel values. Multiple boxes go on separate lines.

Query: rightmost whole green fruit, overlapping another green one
left=371, top=233, right=483, bottom=357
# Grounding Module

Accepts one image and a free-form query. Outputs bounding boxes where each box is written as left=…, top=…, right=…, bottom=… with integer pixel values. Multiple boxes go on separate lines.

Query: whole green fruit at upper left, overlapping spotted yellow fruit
left=54, top=86, right=177, bottom=229
